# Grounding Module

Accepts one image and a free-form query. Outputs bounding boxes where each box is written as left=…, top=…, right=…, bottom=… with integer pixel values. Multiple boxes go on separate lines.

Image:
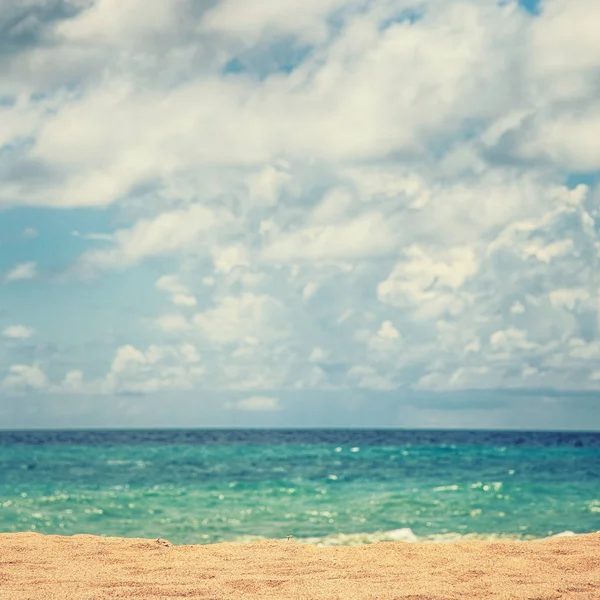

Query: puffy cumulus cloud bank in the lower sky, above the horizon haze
left=3, top=171, right=597, bottom=393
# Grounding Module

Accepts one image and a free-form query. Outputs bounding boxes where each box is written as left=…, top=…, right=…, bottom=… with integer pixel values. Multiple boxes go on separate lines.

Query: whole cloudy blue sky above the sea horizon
left=0, top=0, right=600, bottom=429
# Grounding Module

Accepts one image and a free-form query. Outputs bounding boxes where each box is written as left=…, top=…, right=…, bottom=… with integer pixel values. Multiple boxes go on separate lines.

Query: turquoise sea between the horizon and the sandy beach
left=0, top=430, right=600, bottom=544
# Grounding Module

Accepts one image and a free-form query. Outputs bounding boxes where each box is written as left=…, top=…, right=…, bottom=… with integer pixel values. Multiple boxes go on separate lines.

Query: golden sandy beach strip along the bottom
left=0, top=533, right=600, bottom=600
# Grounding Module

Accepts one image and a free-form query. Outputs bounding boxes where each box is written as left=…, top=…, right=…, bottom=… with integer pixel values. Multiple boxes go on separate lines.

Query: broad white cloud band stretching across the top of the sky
left=3, top=0, right=598, bottom=206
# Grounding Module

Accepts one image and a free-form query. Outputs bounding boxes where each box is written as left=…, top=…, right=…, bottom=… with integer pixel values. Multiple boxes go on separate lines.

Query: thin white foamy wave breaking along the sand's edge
left=235, top=527, right=577, bottom=547
